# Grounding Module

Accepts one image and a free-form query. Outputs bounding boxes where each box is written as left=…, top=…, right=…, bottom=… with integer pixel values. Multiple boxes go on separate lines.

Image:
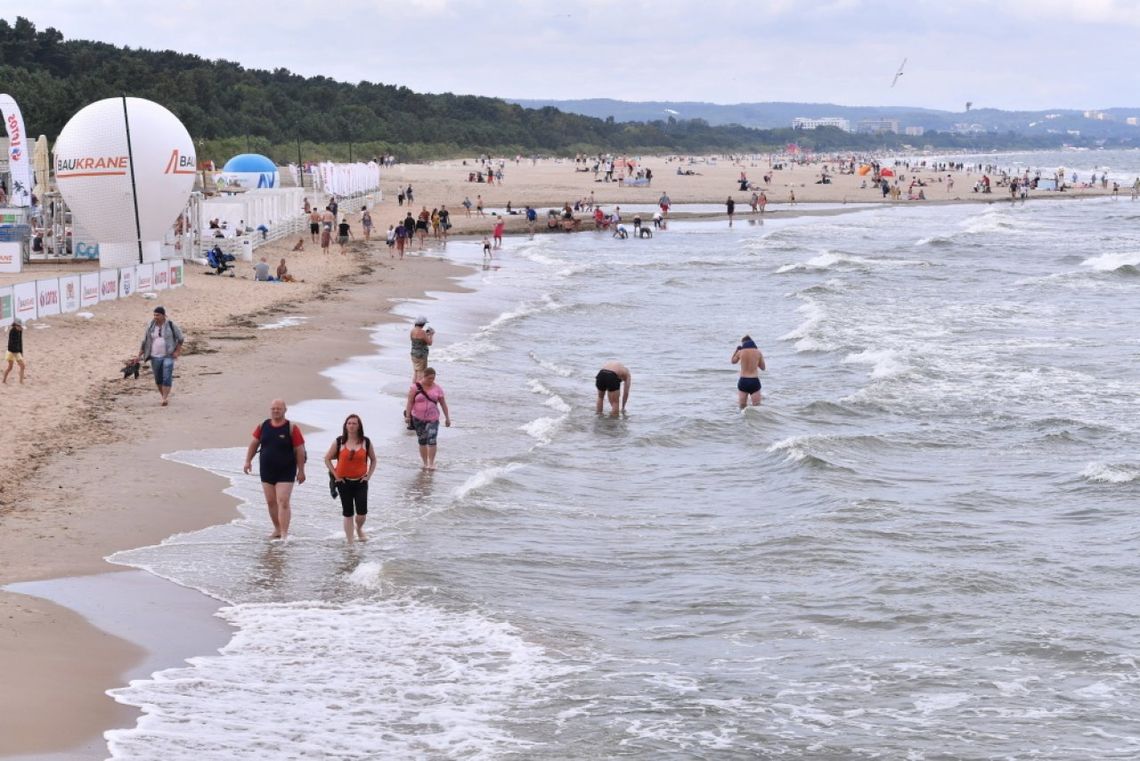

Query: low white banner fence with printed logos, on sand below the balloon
left=0, top=259, right=186, bottom=327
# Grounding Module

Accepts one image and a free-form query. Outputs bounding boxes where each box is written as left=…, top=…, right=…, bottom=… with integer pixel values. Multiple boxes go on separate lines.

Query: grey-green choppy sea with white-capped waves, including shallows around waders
left=106, top=152, right=1140, bottom=761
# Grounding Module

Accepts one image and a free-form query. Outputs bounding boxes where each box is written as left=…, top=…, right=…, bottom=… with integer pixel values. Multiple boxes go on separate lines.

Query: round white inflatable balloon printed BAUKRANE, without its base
left=55, top=98, right=197, bottom=247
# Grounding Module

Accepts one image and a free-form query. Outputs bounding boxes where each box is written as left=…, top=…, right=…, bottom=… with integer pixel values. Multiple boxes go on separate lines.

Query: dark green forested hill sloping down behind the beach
left=0, top=17, right=1103, bottom=163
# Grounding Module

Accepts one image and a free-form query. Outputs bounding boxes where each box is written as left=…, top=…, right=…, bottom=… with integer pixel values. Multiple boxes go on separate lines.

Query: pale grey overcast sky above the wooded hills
left=3, top=0, right=1140, bottom=111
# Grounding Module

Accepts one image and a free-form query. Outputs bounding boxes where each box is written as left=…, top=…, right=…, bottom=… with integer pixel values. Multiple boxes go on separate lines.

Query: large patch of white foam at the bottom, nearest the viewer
left=106, top=599, right=562, bottom=761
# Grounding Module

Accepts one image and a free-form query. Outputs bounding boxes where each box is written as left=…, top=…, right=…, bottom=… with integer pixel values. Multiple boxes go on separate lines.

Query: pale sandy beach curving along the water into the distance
left=0, top=152, right=1112, bottom=758
